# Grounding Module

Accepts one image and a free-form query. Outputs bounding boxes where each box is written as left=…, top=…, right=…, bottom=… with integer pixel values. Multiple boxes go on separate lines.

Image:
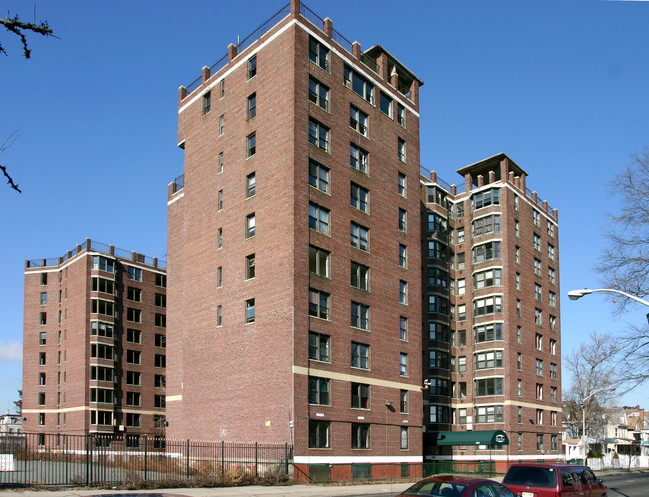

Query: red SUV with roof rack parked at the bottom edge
left=503, top=463, right=607, bottom=497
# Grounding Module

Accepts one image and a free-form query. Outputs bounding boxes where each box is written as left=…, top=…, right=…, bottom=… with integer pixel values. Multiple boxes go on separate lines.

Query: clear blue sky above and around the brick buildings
left=0, top=0, right=649, bottom=411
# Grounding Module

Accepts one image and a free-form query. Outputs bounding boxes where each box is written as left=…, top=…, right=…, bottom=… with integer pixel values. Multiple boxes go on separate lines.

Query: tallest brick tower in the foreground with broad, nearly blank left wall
left=167, top=0, right=423, bottom=463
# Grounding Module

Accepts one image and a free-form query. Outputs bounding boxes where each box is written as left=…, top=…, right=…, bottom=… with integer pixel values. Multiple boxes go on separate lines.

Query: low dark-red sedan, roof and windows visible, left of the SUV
left=399, top=475, right=515, bottom=497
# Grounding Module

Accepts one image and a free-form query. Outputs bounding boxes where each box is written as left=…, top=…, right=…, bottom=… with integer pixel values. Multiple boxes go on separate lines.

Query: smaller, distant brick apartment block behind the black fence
left=22, top=239, right=167, bottom=437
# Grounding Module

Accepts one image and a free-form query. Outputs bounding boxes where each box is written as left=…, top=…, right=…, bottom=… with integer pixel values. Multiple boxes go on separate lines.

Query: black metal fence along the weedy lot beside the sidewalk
left=0, top=433, right=293, bottom=487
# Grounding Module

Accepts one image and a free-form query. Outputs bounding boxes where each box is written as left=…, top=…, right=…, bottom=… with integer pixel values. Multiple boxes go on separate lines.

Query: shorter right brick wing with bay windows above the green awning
left=422, top=154, right=561, bottom=461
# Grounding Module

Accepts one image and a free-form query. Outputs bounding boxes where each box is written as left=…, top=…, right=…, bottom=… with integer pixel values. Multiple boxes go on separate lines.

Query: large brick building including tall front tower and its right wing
left=167, top=0, right=561, bottom=464
